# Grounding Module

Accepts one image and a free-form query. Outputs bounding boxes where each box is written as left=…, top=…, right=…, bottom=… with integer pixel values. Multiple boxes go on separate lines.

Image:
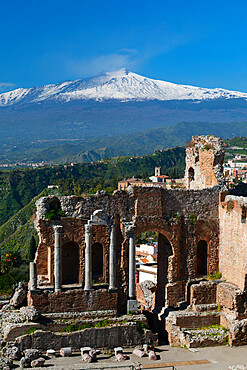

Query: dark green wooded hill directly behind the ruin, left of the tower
left=0, top=147, right=185, bottom=225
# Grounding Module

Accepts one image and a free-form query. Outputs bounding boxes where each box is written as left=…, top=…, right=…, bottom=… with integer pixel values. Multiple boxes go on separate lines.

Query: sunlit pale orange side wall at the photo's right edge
left=219, top=195, right=247, bottom=291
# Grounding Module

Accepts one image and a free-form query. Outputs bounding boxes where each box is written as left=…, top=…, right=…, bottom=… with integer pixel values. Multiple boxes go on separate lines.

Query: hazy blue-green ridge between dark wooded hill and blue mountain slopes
left=0, top=122, right=247, bottom=164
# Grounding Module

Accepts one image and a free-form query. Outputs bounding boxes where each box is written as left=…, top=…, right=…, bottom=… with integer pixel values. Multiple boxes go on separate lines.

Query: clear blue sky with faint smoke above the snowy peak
left=0, top=0, right=247, bottom=92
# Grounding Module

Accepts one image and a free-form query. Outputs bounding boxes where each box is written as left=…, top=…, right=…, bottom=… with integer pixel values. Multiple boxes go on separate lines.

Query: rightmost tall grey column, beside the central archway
left=128, top=225, right=136, bottom=299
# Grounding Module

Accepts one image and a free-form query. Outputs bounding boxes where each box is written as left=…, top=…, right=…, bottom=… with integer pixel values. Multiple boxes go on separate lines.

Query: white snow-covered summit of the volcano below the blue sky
left=0, top=69, right=247, bottom=106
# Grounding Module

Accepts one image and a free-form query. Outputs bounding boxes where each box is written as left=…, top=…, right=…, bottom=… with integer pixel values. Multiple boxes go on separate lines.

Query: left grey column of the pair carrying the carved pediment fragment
left=84, top=224, right=93, bottom=290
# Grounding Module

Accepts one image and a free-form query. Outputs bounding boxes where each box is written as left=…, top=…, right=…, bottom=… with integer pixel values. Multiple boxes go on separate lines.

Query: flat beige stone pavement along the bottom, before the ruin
left=13, top=345, right=247, bottom=370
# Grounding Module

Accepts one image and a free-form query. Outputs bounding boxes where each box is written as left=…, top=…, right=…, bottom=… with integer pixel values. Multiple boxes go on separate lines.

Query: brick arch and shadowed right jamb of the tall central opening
left=136, top=226, right=175, bottom=307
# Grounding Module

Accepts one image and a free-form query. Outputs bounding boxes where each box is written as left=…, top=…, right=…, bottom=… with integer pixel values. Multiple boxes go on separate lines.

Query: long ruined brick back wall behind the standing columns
left=35, top=186, right=219, bottom=312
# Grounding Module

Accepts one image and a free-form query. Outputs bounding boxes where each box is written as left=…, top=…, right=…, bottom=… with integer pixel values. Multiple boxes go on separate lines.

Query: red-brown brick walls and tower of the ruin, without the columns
left=29, top=136, right=247, bottom=330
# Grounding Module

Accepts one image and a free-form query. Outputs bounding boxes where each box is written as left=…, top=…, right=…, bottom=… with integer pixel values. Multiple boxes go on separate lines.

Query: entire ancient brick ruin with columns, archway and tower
left=9, top=136, right=247, bottom=347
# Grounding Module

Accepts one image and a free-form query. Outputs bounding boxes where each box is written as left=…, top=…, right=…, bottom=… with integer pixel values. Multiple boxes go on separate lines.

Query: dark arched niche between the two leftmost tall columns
left=62, top=242, right=79, bottom=284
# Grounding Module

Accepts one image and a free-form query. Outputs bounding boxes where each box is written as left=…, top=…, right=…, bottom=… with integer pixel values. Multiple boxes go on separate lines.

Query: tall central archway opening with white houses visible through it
left=136, top=231, right=173, bottom=307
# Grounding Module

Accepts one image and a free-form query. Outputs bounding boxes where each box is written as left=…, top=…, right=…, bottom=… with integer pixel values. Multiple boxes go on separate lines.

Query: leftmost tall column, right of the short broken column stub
left=53, top=225, right=62, bottom=292
